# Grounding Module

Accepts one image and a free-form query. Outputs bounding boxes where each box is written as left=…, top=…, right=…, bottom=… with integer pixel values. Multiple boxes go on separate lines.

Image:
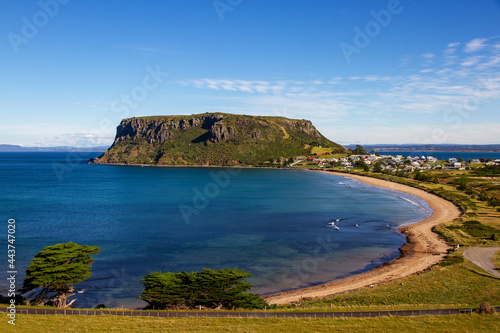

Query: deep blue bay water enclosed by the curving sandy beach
left=0, top=153, right=431, bottom=308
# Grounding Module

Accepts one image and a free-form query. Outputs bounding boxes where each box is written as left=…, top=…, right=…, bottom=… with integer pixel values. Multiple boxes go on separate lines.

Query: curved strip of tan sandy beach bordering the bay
left=265, top=171, right=461, bottom=304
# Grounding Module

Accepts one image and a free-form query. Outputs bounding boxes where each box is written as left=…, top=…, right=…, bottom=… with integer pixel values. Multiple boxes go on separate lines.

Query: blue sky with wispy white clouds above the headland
left=0, top=0, right=500, bottom=147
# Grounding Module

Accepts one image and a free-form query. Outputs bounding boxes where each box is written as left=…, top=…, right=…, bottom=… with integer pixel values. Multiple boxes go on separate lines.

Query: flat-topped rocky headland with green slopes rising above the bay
left=93, top=113, right=345, bottom=166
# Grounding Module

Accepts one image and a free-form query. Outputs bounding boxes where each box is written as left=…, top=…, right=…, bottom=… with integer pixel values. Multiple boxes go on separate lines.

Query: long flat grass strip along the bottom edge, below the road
left=0, top=314, right=500, bottom=333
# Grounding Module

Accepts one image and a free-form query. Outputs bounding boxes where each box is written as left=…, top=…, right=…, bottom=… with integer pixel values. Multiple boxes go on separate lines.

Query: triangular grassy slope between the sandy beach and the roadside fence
left=290, top=260, right=500, bottom=311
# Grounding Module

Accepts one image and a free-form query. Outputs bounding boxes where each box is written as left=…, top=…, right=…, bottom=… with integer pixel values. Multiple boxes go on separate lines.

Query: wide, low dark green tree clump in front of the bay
left=139, top=268, right=268, bottom=309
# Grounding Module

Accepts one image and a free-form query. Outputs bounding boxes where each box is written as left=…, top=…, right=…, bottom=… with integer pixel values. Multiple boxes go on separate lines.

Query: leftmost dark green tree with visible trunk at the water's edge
left=21, top=242, right=101, bottom=308
